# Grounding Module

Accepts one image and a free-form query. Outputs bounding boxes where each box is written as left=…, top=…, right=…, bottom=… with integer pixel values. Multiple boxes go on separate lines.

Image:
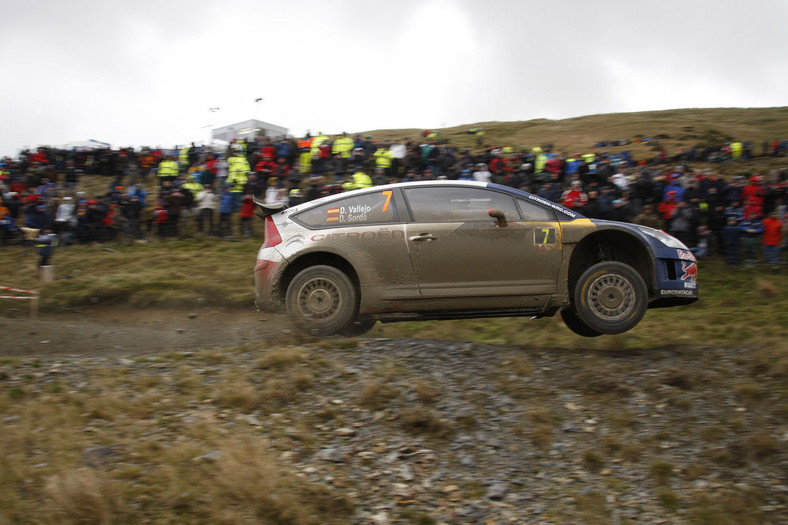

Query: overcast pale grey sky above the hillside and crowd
left=0, top=0, right=788, bottom=155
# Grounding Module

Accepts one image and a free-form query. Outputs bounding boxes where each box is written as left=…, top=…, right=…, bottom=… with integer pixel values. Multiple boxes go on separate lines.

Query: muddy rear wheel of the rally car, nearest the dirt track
left=285, top=266, right=356, bottom=337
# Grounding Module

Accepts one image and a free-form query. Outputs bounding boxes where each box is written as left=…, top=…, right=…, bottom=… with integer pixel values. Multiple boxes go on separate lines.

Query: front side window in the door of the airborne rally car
left=403, top=187, right=520, bottom=222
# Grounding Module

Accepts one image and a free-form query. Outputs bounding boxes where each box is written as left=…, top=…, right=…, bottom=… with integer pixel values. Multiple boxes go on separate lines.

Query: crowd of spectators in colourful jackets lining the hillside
left=0, top=130, right=788, bottom=265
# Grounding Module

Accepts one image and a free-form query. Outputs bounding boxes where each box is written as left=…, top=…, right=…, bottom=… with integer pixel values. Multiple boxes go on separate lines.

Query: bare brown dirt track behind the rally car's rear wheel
left=0, top=308, right=291, bottom=356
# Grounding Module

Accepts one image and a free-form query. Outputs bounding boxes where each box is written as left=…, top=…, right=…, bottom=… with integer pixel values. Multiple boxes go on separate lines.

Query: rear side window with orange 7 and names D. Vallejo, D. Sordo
left=293, top=190, right=397, bottom=228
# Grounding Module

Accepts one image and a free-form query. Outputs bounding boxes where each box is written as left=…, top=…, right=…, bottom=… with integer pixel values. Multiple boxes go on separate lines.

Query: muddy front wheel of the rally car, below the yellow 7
left=574, top=261, right=648, bottom=334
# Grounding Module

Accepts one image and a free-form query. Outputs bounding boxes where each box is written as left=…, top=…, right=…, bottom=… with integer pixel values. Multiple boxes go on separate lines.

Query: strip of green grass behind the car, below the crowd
left=0, top=221, right=788, bottom=352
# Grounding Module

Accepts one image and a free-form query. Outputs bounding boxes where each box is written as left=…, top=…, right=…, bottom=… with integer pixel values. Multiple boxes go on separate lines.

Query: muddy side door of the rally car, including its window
left=403, top=186, right=561, bottom=298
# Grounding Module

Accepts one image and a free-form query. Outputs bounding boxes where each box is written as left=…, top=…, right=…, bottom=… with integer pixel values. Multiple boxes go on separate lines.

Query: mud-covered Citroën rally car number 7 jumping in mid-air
left=254, top=181, right=698, bottom=337
